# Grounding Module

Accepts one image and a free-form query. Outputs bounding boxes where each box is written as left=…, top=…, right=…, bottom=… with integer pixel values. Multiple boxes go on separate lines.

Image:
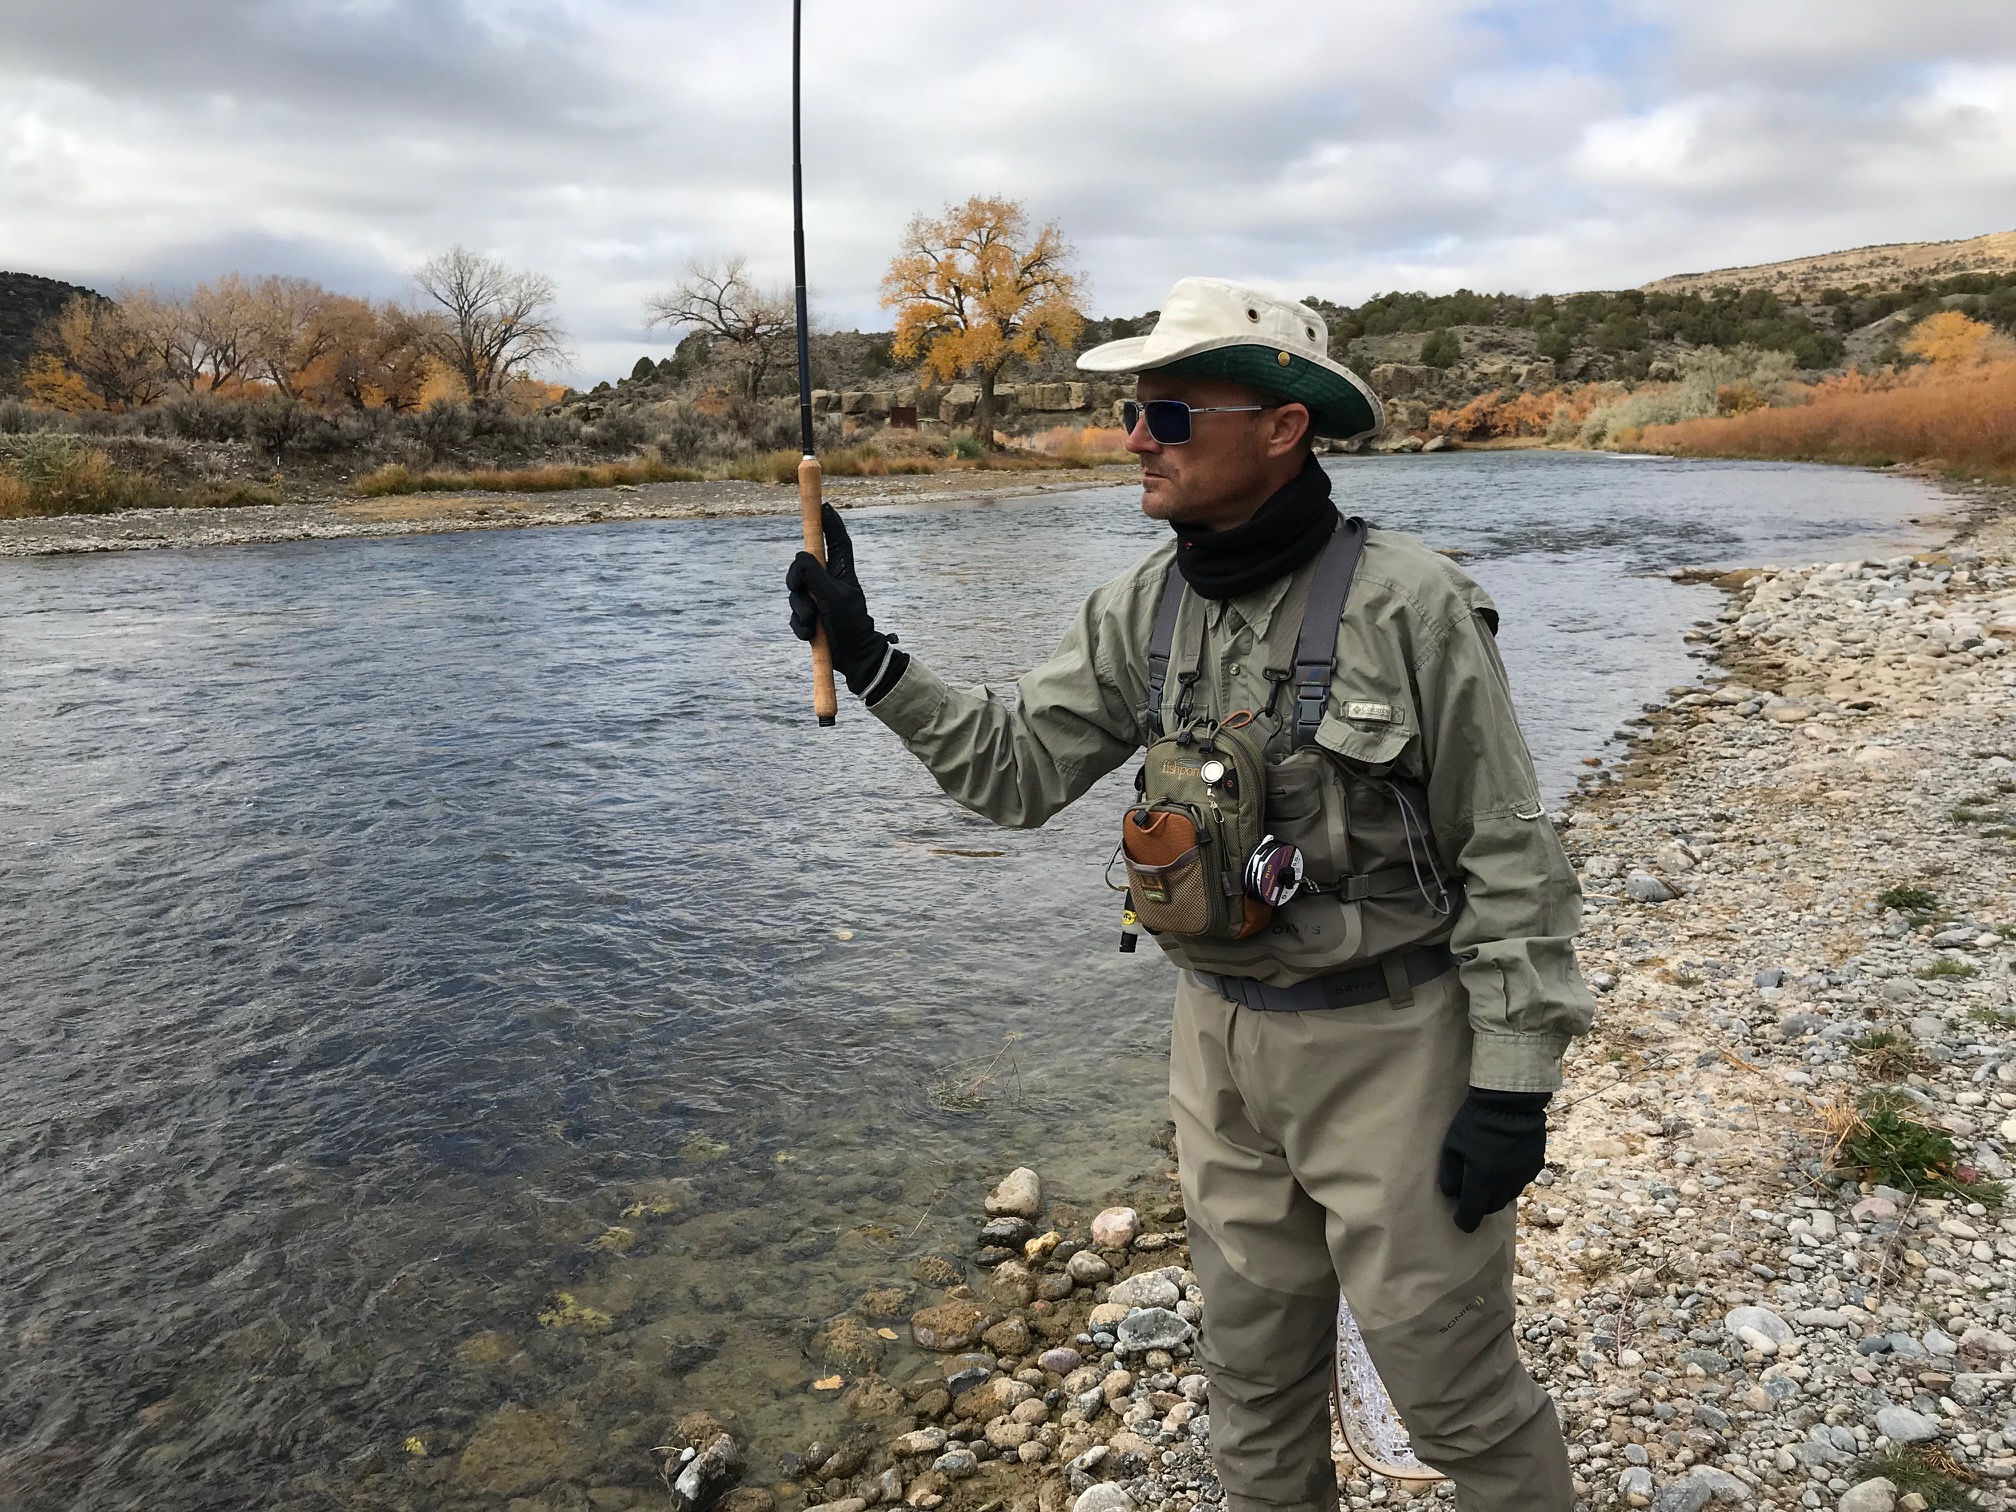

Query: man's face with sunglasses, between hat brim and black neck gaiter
left=1127, top=371, right=1308, bottom=530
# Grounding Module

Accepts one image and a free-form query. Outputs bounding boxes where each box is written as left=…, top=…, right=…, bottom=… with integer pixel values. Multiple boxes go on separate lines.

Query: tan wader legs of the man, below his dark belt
left=1169, top=972, right=1574, bottom=1512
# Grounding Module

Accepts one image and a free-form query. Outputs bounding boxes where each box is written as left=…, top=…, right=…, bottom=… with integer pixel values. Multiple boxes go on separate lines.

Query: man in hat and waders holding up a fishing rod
left=788, top=278, right=1593, bottom=1512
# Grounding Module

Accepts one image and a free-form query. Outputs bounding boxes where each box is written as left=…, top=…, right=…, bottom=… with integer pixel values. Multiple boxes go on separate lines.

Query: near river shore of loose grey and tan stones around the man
left=649, top=487, right=2016, bottom=1512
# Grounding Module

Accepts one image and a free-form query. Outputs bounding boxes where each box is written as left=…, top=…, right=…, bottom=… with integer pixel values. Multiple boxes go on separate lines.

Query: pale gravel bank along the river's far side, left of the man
left=0, top=468, right=1135, bottom=556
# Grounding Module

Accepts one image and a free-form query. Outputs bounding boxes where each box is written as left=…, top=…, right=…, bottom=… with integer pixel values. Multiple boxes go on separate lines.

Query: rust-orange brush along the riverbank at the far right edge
left=1631, top=363, right=2016, bottom=482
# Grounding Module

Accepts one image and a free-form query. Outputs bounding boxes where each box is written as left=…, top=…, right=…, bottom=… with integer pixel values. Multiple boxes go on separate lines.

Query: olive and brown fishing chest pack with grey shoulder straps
left=1117, top=518, right=1452, bottom=980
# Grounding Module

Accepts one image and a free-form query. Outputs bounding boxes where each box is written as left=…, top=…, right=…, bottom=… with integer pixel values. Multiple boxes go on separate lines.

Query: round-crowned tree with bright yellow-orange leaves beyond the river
left=883, top=196, right=1085, bottom=446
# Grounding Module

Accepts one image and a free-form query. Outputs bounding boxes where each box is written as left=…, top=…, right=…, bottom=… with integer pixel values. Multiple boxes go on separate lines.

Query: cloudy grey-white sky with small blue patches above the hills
left=0, top=0, right=2016, bottom=381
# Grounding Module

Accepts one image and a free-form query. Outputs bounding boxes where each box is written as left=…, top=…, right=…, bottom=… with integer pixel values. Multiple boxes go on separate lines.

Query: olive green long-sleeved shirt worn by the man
left=871, top=530, right=1595, bottom=1093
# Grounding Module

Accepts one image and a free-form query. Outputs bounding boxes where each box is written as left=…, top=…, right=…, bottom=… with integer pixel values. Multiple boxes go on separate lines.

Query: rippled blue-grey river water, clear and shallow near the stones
left=0, top=454, right=1939, bottom=1508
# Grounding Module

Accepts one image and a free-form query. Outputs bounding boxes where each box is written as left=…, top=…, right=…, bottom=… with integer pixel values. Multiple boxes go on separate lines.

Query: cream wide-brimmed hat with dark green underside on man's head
left=1079, top=278, right=1385, bottom=442
